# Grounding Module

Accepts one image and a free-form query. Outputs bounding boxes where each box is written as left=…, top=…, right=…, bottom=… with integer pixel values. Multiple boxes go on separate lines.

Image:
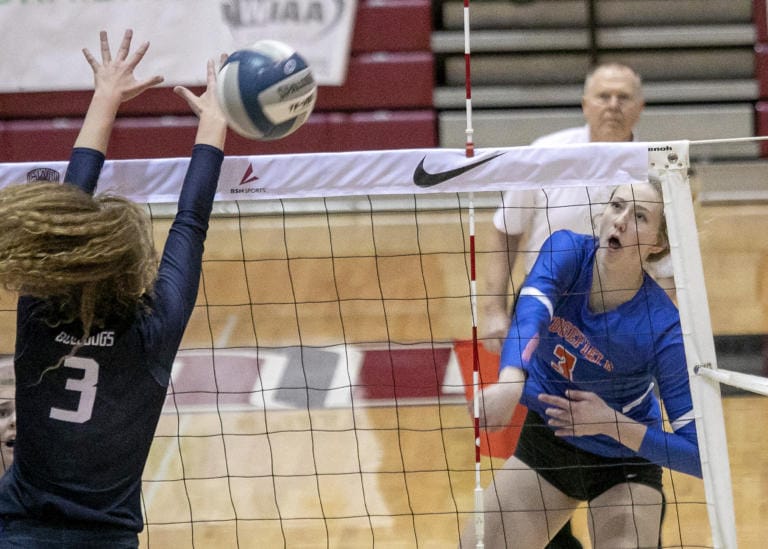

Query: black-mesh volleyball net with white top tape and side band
left=0, top=142, right=760, bottom=548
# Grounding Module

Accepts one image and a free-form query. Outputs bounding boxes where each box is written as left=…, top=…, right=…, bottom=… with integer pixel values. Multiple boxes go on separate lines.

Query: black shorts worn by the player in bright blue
left=515, top=411, right=662, bottom=501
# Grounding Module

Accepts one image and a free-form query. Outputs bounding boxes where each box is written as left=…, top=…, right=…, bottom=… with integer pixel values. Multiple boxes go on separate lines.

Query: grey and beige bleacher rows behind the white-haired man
left=432, top=0, right=768, bottom=161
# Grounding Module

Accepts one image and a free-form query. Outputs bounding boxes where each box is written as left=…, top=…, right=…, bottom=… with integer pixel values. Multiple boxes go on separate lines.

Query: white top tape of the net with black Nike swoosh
left=0, top=143, right=658, bottom=203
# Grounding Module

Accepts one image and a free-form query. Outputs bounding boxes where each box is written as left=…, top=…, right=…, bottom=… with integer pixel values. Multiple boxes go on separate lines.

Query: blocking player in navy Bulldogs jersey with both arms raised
left=0, top=30, right=226, bottom=549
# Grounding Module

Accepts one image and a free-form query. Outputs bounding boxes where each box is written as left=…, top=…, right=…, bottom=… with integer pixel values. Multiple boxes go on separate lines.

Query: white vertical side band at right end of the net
left=648, top=141, right=737, bottom=549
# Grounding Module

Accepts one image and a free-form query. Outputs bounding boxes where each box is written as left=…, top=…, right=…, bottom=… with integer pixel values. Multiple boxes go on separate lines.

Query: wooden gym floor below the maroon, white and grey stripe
left=135, top=396, right=768, bottom=549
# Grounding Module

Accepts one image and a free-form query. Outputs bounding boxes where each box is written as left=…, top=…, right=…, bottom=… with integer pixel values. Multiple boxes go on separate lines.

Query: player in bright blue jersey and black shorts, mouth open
left=462, top=182, right=701, bottom=548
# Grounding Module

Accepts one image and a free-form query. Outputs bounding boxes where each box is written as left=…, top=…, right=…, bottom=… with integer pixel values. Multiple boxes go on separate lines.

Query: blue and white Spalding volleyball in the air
left=217, top=40, right=317, bottom=141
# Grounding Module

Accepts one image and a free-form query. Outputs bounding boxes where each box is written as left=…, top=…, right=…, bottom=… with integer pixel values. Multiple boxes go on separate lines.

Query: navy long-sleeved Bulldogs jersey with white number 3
left=0, top=145, right=223, bottom=532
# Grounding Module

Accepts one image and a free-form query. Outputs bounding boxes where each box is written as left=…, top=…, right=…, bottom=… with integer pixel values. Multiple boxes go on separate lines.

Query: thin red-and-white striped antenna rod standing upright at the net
left=463, top=0, right=485, bottom=549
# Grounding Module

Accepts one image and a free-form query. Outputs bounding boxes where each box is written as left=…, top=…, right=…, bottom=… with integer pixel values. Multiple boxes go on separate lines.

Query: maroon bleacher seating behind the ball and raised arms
left=0, top=0, right=437, bottom=162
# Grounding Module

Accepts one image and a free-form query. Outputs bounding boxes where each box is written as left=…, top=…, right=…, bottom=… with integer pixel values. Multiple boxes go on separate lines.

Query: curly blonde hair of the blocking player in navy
left=0, top=182, right=157, bottom=337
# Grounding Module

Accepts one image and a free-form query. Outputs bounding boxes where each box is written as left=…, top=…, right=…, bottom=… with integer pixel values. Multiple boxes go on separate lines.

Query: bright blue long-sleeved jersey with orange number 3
left=500, top=231, right=701, bottom=476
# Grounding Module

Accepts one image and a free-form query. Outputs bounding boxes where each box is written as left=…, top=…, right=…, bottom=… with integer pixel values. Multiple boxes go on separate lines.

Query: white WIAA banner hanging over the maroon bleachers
left=0, top=0, right=357, bottom=93
